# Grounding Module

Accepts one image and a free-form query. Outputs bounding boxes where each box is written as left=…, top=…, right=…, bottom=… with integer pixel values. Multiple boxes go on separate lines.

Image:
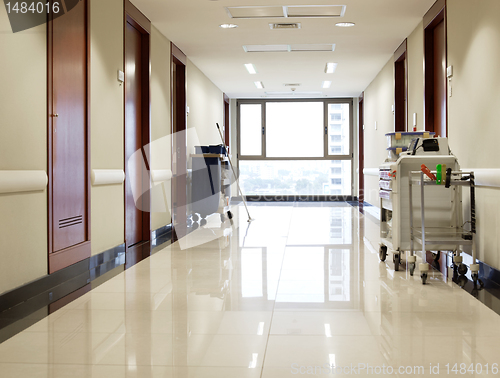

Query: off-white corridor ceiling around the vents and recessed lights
left=132, top=0, right=435, bottom=98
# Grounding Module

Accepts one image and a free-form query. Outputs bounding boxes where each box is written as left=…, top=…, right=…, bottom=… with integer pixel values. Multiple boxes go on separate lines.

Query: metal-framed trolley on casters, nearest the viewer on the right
left=408, top=168, right=479, bottom=285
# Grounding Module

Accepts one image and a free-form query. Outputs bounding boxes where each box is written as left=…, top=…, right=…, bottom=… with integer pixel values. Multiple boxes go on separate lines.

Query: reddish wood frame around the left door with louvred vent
left=47, top=0, right=91, bottom=274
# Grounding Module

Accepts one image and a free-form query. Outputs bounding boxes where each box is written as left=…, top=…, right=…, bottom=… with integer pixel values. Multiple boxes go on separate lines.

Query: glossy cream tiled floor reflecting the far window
left=0, top=203, right=500, bottom=378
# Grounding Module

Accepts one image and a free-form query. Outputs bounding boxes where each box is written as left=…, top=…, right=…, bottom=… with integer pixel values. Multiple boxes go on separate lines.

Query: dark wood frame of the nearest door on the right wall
left=423, top=0, right=448, bottom=136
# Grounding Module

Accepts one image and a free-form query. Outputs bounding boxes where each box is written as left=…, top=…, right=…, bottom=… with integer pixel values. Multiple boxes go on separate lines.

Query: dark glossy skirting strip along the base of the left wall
left=0, top=225, right=172, bottom=343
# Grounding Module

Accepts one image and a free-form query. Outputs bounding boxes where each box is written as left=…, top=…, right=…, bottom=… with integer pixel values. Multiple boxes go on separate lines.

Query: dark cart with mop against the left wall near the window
left=191, top=146, right=233, bottom=226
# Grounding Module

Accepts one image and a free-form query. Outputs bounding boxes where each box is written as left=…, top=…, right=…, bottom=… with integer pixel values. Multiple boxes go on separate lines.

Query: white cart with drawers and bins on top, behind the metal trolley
left=379, top=132, right=461, bottom=275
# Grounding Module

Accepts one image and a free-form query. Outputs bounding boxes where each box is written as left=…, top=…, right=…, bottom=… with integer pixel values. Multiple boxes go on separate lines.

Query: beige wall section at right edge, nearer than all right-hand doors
left=447, top=0, right=500, bottom=269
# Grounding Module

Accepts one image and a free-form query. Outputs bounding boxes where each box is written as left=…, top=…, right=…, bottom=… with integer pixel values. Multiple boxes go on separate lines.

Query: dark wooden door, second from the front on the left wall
left=125, top=4, right=149, bottom=247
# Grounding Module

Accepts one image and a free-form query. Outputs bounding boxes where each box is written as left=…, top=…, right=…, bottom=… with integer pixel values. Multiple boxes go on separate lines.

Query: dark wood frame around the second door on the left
left=123, top=0, right=151, bottom=247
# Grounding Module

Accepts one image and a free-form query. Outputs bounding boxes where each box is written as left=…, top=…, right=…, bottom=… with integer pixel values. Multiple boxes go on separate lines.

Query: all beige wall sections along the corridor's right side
left=365, top=0, right=500, bottom=269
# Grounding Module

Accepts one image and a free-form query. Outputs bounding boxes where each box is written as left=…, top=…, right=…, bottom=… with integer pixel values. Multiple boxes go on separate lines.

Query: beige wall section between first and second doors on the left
left=90, top=0, right=124, bottom=255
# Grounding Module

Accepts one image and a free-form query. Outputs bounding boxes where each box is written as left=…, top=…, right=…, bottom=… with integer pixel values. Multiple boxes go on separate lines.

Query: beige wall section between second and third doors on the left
left=151, top=27, right=172, bottom=230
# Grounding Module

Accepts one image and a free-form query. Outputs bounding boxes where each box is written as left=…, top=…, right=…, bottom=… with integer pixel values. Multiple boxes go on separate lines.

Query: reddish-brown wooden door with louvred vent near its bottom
left=47, top=1, right=90, bottom=273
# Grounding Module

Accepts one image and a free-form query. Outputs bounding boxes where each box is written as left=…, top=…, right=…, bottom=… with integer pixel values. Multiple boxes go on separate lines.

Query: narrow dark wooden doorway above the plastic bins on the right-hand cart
left=394, top=39, right=408, bottom=131
